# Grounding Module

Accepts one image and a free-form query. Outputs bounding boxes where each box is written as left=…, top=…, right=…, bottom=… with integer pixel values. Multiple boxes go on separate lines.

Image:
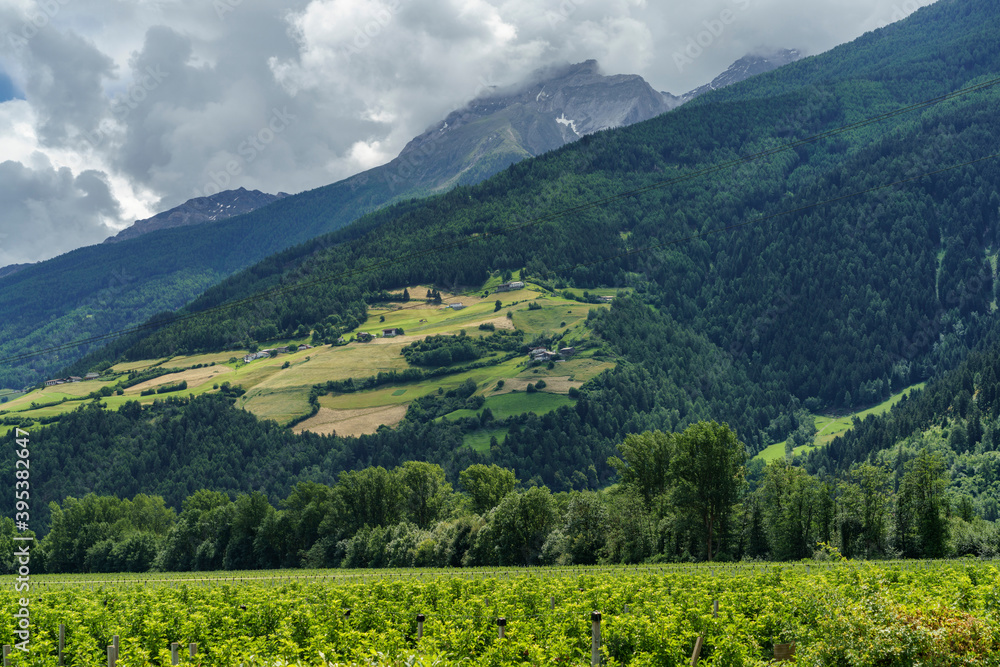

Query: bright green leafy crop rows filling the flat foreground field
left=0, top=560, right=1000, bottom=667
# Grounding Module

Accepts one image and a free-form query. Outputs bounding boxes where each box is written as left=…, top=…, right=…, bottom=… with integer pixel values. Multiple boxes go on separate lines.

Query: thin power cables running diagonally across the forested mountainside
left=0, top=77, right=1000, bottom=364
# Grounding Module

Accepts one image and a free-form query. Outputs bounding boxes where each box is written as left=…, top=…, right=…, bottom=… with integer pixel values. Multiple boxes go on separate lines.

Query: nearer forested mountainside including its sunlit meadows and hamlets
left=0, top=0, right=1000, bottom=567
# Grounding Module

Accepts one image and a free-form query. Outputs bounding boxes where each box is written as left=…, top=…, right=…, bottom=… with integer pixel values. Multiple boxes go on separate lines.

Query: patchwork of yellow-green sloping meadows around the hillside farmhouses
left=0, top=275, right=616, bottom=428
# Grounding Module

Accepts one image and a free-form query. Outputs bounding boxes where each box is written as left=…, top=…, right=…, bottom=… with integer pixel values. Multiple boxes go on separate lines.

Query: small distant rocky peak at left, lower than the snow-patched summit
left=104, top=188, right=288, bottom=243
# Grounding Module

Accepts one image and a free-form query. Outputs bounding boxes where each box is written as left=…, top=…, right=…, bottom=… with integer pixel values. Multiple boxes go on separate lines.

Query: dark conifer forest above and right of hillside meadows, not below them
left=88, top=0, right=1000, bottom=446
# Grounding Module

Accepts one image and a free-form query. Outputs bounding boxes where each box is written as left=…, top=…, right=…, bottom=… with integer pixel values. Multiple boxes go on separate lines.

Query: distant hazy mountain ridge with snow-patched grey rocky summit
left=0, top=61, right=748, bottom=389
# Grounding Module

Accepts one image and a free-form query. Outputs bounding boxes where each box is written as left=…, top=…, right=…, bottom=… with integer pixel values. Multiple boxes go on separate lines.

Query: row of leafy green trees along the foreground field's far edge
left=0, top=422, right=1000, bottom=573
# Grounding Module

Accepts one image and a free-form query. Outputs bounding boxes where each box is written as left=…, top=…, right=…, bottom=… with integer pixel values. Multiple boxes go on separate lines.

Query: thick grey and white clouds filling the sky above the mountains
left=0, top=0, right=930, bottom=264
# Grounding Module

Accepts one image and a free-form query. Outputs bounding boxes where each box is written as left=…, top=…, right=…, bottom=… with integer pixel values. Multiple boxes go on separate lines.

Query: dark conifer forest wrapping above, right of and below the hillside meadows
left=1, top=0, right=1000, bottom=532
